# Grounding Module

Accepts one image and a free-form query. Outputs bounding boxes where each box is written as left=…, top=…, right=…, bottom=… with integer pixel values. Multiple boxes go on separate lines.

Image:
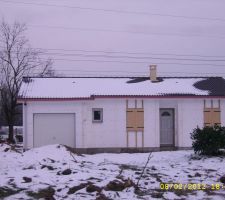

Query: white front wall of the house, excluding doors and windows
left=23, top=97, right=225, bottom=149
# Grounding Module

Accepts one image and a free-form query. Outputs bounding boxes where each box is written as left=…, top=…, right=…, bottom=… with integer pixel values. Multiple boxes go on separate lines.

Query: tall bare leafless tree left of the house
left=0, top=20, right=52, bottom=142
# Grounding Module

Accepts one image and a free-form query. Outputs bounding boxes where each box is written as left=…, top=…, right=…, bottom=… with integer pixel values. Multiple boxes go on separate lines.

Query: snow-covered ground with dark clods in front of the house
left=0, top=144, right=225, bottom=200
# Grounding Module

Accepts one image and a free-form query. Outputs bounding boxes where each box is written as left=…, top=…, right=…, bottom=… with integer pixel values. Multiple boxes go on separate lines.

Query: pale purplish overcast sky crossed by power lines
left=0, top=0, right=225, bottom=76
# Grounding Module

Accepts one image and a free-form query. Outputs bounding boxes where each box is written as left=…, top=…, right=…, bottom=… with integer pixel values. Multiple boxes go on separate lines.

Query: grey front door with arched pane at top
left=160, top=108, right=174, bottom=147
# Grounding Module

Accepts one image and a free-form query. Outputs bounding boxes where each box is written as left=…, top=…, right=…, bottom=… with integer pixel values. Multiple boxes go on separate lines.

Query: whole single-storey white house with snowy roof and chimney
left=19, top=65, right=225, bottom=152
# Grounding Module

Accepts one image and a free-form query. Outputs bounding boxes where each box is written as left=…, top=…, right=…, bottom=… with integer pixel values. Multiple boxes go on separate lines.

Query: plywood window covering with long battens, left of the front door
left=126, top=100, right=144, bottom=147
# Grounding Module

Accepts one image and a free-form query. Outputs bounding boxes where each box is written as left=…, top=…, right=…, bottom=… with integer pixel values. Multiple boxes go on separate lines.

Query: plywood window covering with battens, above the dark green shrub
left=204, top=100, right=221, bottom=126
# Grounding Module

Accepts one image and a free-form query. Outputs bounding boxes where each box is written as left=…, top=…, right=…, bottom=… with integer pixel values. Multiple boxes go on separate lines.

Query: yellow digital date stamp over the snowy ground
left=160, top=183, right=225, bottom=190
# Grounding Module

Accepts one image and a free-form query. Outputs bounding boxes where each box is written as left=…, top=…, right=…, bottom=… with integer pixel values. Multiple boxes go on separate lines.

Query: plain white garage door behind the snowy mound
left=34, top=113, right=75, bottom=147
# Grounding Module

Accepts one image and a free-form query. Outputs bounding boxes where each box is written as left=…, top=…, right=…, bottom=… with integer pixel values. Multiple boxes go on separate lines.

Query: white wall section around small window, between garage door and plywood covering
left=84, top=99, right=126, bottom=148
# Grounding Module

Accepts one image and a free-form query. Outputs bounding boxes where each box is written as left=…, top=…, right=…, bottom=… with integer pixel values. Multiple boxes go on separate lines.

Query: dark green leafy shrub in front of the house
left=191, top=126, right=225, bottom=155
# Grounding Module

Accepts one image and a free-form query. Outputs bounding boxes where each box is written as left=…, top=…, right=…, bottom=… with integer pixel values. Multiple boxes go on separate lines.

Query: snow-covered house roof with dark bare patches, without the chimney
left=19, top=77, right=225, bottom=99
